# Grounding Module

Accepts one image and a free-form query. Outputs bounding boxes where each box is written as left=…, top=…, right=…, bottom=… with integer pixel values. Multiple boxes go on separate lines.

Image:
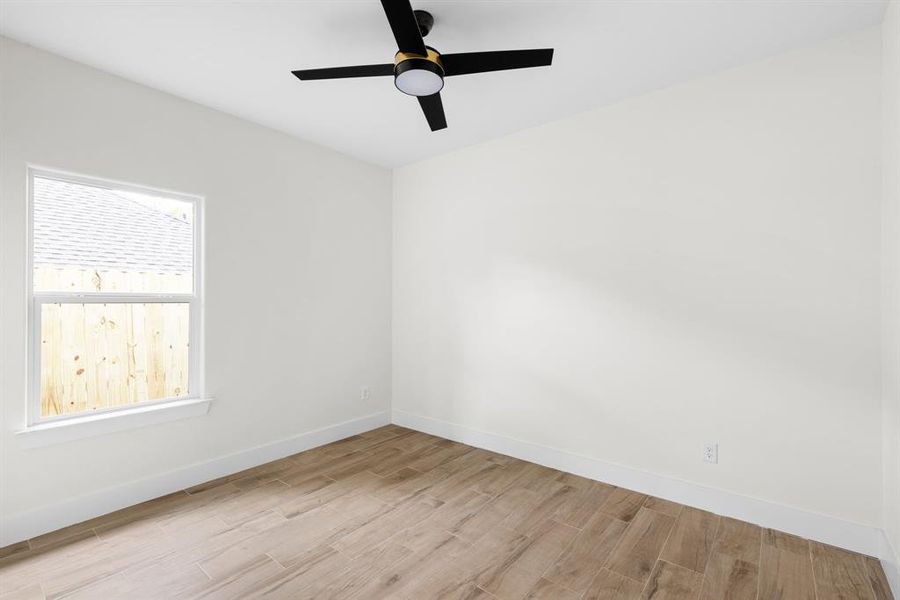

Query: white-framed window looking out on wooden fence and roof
left=29, top=170, right=201, bottom=425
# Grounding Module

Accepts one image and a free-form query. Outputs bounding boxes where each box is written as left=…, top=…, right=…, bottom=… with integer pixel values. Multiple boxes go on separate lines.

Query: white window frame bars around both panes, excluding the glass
left=26, top=165, right=205, bottom=429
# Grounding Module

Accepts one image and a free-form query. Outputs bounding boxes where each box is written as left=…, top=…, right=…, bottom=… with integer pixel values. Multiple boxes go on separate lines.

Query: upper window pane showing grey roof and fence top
left=32, top=176, right=194, bottom=294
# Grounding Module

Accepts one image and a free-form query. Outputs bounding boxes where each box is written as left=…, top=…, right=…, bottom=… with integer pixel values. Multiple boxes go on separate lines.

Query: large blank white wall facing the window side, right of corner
left=393, top=28, right=882, bottom=527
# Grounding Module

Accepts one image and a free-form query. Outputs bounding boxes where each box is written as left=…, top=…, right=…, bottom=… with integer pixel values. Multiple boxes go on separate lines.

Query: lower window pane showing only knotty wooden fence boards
left=41, top=303, right=190, bottom=417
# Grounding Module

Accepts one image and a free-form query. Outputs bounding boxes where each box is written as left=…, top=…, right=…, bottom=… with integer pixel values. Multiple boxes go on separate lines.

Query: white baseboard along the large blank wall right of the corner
left=391, top=409, right=884, bottom=556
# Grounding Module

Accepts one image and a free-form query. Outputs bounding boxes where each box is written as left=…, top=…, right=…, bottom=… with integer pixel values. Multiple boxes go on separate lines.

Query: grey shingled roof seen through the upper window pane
left=34, top=177, right=193, bottom=273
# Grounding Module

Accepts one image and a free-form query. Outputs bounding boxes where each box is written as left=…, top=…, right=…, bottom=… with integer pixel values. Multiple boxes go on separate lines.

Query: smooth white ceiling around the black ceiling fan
left=0, top=0, right=886, bottom=166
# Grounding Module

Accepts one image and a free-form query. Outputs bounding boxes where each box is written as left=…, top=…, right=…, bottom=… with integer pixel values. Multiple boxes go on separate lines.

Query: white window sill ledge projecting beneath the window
left=16, top=398, right=212, bottom=448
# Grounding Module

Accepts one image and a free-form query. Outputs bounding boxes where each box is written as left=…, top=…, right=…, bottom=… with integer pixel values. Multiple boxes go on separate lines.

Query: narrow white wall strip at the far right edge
left=882, top=0, right=900, bottom=586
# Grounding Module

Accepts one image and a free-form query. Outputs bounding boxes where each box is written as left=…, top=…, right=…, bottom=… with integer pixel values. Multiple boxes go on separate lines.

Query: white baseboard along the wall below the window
left=0, top=412, right=390, bottom=548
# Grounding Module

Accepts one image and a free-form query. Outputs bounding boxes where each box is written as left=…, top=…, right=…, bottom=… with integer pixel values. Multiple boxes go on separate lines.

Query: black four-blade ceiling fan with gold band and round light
left=292, top=0, right=553, bottom=131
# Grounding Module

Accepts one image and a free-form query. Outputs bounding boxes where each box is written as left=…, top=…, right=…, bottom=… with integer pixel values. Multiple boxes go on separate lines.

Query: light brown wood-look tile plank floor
left=0, top=425, right=891, bottom=600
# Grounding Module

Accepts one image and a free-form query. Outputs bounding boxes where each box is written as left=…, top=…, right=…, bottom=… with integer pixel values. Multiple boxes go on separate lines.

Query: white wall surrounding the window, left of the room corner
left=0, top=39, right=391, bottom=546
